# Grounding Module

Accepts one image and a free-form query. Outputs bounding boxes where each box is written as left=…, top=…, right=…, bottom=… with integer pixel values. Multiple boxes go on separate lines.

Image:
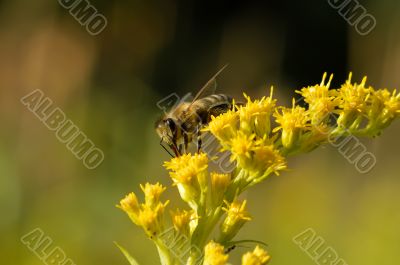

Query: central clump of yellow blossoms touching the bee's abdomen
left=208, top=88, right=286, bottom=186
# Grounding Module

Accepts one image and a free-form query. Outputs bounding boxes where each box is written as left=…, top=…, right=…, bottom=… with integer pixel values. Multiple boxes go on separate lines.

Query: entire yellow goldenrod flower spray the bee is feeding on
left=119, top=74, right=400, bottom=265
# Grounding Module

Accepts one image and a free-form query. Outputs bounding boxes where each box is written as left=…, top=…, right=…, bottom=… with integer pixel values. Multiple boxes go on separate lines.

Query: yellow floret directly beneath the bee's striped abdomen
left=203, top=110, right=239, bottom=145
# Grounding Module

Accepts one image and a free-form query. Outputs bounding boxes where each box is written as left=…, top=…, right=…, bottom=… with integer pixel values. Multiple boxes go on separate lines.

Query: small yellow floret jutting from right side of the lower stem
left=220, top=200, right=251, bottom=242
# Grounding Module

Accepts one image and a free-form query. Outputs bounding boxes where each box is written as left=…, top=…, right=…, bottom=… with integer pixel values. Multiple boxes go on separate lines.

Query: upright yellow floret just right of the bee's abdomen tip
left=238, top=88, right=276, bottom=137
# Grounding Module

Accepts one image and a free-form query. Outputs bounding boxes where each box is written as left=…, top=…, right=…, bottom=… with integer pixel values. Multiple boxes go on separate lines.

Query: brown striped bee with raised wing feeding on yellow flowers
left=155, top=65, right=233, bottom=156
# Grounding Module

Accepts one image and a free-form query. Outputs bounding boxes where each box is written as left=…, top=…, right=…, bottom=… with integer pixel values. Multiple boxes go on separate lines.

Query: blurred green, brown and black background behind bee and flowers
left=0, top=0, right=400, bottom=265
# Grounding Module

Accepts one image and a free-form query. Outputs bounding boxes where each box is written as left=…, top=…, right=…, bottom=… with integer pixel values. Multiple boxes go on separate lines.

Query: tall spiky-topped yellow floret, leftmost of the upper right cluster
left=296, top=73, right=340, bottom=125
